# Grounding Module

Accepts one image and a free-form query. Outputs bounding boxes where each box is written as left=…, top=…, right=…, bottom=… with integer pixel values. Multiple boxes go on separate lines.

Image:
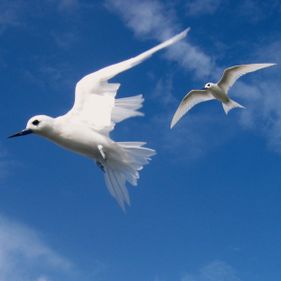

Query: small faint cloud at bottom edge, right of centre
left=181, top=261, right=241, bottom=281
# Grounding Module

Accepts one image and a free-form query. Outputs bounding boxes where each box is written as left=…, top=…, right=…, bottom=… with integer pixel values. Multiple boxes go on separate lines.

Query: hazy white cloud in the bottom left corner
left=0, top=212, right=73, bottom=281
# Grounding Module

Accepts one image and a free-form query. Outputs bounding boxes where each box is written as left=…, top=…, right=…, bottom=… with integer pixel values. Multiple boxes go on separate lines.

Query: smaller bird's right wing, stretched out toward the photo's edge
left=218, top=63, right=275, bottom=93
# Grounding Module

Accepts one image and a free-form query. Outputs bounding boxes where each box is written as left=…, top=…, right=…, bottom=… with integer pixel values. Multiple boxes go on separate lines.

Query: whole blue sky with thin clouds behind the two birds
left=0, top=0, right=281, bottom=281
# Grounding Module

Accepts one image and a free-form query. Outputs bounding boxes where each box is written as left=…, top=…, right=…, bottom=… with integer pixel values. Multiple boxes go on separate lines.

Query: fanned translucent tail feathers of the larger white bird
left=103, top=142, right=155, bottom=211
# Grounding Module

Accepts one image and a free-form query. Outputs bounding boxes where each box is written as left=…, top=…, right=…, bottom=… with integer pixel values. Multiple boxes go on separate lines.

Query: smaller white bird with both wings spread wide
left=170, top=63, right=275, bottom=128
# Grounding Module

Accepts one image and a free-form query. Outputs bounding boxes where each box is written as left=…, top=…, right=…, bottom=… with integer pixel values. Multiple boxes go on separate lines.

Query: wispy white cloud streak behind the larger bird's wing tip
left=105, top=0, right=214, bottom=77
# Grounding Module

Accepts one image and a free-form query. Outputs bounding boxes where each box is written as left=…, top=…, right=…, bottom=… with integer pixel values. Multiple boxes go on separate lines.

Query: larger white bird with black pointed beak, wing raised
left=9, top=29, right=189, bottom=210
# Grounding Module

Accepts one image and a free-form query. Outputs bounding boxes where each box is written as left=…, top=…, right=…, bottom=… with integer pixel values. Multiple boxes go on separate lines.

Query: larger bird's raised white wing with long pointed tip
left=67, top=29, right=189, bottom=134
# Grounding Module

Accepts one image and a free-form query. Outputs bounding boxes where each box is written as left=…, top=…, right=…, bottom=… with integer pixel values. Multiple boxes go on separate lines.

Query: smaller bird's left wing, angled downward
left=170, top=90, right=214, bottom=128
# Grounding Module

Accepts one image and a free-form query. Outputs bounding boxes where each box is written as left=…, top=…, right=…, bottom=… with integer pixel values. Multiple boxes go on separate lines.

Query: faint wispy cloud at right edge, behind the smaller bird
left=231, top=39, right=281, bottom=153
